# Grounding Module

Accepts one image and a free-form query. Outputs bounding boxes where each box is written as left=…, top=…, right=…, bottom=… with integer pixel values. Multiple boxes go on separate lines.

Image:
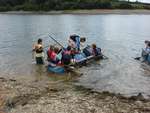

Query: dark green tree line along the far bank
left=0, top=0, right=150, bottom=11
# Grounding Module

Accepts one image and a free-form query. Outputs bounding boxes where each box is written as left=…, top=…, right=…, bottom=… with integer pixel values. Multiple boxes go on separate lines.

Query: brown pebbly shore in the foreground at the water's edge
left=0, top=77, right=150, bottom=113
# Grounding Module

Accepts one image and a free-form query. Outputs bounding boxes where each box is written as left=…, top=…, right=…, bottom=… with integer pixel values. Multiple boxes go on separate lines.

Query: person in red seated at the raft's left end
left=47, top=45, right=60, bottom=64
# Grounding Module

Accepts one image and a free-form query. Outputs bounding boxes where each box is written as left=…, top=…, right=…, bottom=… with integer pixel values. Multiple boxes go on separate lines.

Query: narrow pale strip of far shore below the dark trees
left=0, top=9, right=150, bottom=15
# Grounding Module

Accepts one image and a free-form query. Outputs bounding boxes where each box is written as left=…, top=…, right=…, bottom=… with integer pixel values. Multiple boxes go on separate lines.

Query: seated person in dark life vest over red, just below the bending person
left=61, top=46, right=72, bottom=65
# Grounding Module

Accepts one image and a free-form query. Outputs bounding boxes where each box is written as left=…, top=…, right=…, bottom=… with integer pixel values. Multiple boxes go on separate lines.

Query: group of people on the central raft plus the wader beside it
left=33, top=35, right=101, bottom=65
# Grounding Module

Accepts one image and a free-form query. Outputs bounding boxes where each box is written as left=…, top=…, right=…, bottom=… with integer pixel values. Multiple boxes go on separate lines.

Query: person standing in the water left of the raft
left=33, top=39, right=44, bottom=64
